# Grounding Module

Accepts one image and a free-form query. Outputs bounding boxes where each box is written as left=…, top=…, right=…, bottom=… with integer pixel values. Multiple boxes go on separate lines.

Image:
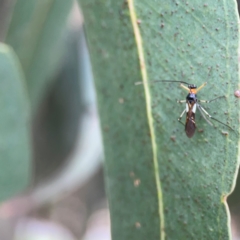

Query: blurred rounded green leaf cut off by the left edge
left=0, top=44, right=31, bottom=201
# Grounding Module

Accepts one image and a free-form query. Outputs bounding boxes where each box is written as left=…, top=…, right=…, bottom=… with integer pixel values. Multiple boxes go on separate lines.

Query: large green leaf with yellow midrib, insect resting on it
left=80, top=0, right=239, bottom=240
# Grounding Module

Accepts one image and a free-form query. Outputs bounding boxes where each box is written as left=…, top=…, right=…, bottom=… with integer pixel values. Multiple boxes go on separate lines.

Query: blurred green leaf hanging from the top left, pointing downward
left=6, top=0, right=73, bottom=109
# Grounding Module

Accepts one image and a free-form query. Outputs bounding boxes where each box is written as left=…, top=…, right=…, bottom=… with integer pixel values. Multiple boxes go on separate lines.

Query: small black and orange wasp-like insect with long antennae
left=135, top=80, right=234, bottom=138
